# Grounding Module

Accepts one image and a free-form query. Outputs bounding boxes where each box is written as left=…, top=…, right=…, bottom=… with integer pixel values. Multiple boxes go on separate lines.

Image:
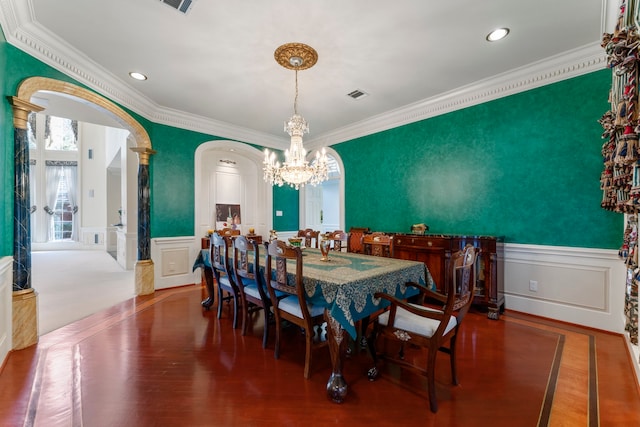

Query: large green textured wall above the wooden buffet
left=333, top=70, right=623, bottom=248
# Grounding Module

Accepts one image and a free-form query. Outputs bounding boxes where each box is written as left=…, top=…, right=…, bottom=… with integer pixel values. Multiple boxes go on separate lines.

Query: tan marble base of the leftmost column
left=12, top=288, right=38, bottom=350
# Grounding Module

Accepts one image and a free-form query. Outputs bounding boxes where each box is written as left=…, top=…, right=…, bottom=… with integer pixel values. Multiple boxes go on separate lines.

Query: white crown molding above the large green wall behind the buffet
left=305, top=44, right=607, bottom=149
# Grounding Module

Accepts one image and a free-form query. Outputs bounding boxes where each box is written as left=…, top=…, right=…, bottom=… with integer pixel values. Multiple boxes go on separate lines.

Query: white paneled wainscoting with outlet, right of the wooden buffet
left=504, top=244, right=625, bottom=334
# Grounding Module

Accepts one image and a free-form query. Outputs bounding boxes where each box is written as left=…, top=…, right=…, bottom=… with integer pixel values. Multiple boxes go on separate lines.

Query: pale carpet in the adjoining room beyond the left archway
left=31, top=250, right=135, bottom=335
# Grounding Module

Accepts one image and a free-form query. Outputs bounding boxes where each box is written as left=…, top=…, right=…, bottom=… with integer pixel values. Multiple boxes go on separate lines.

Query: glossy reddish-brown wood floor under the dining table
left=0, top=286, right=640, bottom=427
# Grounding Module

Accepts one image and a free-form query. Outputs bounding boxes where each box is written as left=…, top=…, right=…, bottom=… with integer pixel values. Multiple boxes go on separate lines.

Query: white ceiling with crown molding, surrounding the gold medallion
left=0, top=0, right=618, bottom=148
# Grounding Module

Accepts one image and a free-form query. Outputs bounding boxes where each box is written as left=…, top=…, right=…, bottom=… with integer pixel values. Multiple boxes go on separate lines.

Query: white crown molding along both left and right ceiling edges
left=0, top=0, right=606, bottom=149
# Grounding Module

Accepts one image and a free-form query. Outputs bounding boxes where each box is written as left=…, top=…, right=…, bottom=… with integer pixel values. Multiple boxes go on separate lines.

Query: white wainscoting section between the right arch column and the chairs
left=151, top=236, right=201, bottom=289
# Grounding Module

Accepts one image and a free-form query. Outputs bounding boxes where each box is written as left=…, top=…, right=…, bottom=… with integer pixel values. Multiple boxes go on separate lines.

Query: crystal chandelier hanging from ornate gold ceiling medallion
left=263, top=43, right=328, bottom=190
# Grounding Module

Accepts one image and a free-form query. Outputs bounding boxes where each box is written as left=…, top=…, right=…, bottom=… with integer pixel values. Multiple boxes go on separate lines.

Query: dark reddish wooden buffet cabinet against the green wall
left=393, top=234, right=504, bottom=320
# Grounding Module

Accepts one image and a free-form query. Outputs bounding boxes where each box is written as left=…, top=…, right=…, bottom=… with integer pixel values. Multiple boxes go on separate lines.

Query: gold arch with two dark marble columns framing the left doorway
left=9, top=77, right=154, bottom=349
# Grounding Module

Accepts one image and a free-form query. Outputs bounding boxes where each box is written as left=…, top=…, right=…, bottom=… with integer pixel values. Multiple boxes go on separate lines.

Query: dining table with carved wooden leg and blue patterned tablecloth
left=193, top=244, right=435, bottom=403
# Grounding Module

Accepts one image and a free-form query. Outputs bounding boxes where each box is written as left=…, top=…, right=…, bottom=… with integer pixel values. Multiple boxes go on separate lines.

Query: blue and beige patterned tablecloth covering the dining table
left=193, top=248, right=434, bottom=338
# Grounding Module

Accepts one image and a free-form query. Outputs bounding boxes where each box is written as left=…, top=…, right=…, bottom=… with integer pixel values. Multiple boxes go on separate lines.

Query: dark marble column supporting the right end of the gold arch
left=131, top=147, right=155, bottom=295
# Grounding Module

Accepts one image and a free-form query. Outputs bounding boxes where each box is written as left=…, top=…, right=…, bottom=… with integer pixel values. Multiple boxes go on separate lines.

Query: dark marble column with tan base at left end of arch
left=7, top=96, right=43, bottom=350
